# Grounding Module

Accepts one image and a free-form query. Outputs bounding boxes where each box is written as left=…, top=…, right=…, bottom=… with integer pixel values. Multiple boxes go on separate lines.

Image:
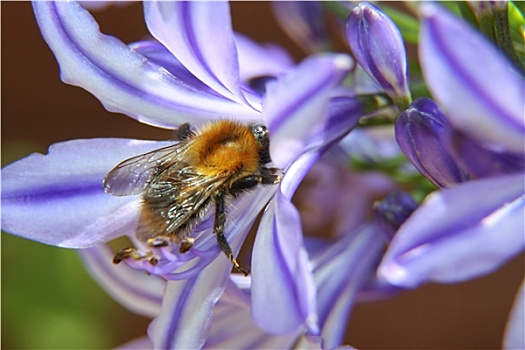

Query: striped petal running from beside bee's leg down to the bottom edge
left=145, top=188, right=274, bottom=349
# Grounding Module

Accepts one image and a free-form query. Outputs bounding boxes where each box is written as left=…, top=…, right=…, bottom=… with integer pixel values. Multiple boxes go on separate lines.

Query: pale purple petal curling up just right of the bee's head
left=263, top=55, right=352, bottom=169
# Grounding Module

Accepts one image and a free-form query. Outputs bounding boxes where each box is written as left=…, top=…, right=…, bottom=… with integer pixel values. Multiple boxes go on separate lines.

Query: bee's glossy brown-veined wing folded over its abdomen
left=136, top=167, right=228, bottom=242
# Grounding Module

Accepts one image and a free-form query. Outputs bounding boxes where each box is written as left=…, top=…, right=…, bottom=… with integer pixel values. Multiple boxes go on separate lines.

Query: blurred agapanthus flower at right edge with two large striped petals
left=379, top=5, right=525, bottom=348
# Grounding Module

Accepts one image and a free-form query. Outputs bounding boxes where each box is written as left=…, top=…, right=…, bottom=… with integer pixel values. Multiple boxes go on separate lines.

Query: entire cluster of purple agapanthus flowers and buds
left=2, top=1, right=525, bottom=349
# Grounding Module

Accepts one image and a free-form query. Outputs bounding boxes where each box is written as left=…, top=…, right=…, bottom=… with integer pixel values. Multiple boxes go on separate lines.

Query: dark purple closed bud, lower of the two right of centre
left=395, top=97, right=469, bottom=187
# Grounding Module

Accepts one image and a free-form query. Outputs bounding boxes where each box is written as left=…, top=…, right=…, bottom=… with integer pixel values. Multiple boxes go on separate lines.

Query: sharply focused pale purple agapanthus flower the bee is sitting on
left=2, top=1, right=361, bottom=348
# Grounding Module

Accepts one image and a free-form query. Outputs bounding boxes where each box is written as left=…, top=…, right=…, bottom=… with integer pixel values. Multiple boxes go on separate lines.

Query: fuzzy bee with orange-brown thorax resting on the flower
left=103, top=120, right=281, bottom=275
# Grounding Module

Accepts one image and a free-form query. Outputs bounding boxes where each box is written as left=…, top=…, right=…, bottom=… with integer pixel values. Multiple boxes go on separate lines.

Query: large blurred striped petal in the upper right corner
left=419, top=5, right=525, bottom=153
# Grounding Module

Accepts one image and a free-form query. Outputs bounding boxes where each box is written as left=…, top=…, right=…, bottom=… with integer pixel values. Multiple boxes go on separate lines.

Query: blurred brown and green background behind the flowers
left=1, top=2, right=524, bottom=349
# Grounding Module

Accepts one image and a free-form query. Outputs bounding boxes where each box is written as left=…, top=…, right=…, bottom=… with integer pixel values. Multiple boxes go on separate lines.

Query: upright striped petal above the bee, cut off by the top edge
left=144, top=1, right=249, bottom=103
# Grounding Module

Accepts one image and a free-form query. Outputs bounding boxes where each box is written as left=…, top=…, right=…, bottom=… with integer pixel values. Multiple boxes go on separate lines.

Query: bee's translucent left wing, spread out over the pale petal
left=102, top=142, right=189, bottom=196
